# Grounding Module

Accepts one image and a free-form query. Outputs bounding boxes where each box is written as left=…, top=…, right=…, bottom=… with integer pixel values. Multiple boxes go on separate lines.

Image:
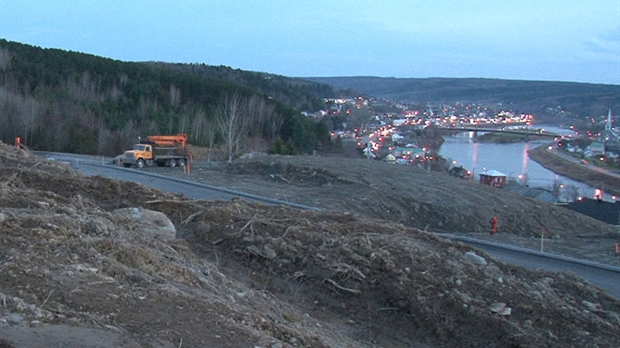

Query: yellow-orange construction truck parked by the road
left=122, top=134, right=191, bottom=168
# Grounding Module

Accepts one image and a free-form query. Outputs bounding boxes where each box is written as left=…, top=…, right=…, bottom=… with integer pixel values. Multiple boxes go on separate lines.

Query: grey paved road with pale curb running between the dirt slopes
left=46, top=155, right=620, bottom=299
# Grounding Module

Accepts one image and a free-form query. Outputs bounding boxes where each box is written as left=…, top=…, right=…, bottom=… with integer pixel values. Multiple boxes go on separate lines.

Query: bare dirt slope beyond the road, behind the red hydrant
left=159, top=151, right=620, bottom=266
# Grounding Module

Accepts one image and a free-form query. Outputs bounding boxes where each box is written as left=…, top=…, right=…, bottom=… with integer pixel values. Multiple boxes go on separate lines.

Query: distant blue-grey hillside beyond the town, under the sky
left=305, top=76, right=620, bottom=122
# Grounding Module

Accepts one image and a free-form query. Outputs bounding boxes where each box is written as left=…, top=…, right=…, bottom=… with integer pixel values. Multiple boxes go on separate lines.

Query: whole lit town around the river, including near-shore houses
left=307, top=92, right=620, bottom=219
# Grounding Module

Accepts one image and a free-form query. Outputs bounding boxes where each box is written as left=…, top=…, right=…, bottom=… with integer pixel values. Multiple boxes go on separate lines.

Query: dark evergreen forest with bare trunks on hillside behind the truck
left=0, top=40, right=333, bottom=156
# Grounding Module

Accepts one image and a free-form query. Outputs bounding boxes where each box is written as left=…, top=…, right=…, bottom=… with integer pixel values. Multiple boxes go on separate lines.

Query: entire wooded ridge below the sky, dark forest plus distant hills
left=0, top=39, right=620, bottom=159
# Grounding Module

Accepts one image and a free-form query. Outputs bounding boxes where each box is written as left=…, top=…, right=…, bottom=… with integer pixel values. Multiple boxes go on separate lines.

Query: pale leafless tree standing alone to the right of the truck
left=215, top=93, right=247, bottom=163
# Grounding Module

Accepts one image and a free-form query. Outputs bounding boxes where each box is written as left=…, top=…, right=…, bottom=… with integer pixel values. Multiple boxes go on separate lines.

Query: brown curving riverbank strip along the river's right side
left=528, top=145, right=620, bottom=196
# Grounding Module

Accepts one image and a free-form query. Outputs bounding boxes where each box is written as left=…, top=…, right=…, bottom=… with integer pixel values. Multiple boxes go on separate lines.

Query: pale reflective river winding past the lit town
left=439, top=126, right=613, bottom=202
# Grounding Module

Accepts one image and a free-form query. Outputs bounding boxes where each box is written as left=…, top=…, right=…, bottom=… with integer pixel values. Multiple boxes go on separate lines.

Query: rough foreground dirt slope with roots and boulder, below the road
left=0, top=144, right=620, bottom=348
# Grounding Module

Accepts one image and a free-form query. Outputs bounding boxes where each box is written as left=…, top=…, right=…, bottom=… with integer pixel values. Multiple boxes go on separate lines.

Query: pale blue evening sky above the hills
left=0, top=0, right=620, bottom=85
